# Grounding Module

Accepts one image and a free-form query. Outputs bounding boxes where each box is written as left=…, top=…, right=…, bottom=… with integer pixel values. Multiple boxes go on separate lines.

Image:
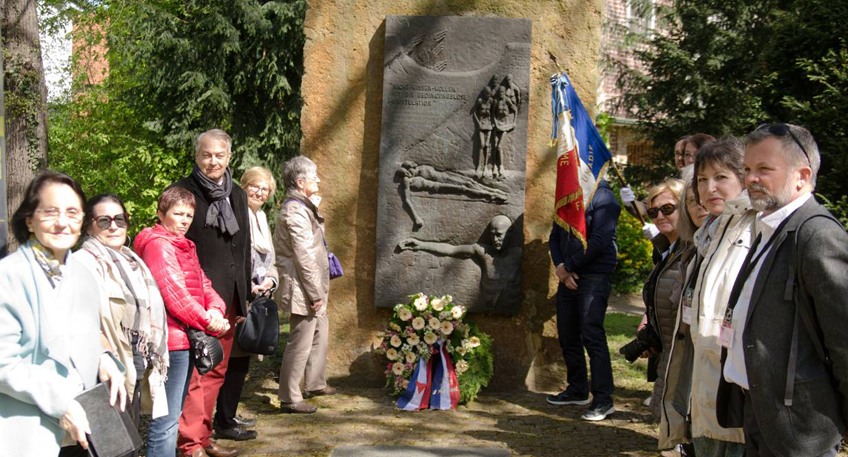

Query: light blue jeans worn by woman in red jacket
left=147, top=349, right=194, bottom=457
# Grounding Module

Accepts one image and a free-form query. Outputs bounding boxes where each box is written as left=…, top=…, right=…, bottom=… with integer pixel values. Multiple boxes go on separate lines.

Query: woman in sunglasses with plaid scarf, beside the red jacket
left=74, top=194, right=168, bottom=455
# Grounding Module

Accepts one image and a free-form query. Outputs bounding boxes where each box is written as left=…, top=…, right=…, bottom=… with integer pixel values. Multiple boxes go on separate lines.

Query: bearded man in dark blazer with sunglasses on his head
left=717, top=124, right=848, bottom=457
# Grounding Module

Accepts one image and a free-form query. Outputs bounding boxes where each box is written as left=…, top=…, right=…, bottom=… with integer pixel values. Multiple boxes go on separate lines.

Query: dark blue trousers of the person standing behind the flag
left=556, top=274, right=613, bottom=406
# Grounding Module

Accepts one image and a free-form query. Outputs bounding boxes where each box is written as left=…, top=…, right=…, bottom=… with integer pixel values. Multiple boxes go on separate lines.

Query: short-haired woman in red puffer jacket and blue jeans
left=135, top=187, right=229, bottom=457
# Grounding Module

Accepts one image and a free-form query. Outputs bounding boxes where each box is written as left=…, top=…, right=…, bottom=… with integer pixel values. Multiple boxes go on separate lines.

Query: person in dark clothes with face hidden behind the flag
left=547, top=179, right=621, bottom=421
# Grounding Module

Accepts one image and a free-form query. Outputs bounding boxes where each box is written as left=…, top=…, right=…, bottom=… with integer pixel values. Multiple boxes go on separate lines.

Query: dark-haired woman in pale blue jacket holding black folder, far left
left=0, top=172, right=126, bottom=457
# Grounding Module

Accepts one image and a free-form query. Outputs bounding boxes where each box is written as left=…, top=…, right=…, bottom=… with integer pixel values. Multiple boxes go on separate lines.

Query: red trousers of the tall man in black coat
left=177, top=305, right=236, bottom=455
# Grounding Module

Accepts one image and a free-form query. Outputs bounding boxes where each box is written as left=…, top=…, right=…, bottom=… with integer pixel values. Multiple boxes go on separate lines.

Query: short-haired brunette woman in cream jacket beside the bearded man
left=680, top=140, right=757, bottom=457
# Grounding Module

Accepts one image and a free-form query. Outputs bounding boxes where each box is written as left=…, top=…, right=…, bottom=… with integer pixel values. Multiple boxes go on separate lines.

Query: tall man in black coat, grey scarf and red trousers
left=175, top=129, right=250, bottom=457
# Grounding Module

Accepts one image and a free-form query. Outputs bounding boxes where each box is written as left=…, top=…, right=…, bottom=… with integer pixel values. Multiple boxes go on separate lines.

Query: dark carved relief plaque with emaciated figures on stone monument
left=375, top=16, right=531, bottom=314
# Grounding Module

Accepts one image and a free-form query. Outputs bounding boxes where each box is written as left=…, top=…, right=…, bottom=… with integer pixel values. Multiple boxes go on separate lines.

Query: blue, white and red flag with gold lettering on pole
left=551, top=73, right=612, bottom=249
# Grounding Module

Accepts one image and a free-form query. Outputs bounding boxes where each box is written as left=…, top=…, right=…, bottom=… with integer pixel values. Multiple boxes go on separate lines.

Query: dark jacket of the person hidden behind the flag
left=548, top=179, right=621, bottom=274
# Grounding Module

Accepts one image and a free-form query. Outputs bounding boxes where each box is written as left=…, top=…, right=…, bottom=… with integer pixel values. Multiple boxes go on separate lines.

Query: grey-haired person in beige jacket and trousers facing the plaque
left=274, top=156, right=335, bottom=414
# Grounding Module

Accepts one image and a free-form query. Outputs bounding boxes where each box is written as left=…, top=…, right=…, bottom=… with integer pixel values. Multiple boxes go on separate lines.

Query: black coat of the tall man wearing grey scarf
left=174, top=175, right=251, bottom=316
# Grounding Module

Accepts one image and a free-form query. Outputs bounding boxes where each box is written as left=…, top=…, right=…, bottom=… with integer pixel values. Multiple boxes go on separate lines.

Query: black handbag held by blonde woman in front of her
left=236, top=295, right=280, bottom=355
